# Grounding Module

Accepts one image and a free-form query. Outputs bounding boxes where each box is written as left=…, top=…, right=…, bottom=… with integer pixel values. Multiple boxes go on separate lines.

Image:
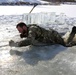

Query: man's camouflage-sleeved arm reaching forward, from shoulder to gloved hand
left=9, top=26, right=38, bottom=47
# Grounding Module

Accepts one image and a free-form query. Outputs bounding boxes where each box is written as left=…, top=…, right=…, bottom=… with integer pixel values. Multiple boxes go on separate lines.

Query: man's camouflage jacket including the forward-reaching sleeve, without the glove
left=19, top=24, right=64, bottom=46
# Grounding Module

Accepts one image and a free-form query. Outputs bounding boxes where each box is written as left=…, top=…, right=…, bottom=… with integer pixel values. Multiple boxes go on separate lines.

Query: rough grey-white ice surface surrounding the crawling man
left=0, top=13, right=76, bottom=75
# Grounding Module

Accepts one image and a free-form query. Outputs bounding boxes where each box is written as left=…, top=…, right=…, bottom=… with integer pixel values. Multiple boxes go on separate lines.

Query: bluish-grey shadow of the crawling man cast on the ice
left=10, top=45, right=65, bottom=65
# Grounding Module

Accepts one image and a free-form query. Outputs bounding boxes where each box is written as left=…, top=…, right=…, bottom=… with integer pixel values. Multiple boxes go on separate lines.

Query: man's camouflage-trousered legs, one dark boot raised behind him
left=48, top=26, right=76, bottom=47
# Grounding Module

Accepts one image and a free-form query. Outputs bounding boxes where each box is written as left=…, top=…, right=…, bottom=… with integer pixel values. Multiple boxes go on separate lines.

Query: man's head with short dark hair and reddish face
left=16, top=22, right=27, bottom=34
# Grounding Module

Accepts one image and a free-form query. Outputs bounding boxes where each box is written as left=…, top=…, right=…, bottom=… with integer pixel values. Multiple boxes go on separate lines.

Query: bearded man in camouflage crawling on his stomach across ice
left=9, top=22, right=76, bottom=47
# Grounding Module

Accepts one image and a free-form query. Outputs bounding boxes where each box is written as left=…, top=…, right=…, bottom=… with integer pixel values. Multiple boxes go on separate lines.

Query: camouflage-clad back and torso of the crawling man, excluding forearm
left=28, top=24, right=64, bottom=44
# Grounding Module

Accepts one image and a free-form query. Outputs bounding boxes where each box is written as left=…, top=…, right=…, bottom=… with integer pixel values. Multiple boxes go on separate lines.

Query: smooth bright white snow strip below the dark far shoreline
left=0, top=4, right=76, bottom=17
